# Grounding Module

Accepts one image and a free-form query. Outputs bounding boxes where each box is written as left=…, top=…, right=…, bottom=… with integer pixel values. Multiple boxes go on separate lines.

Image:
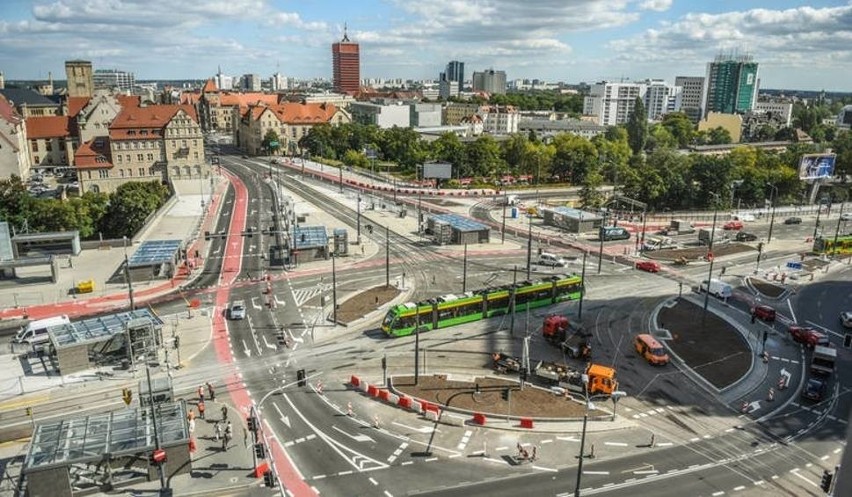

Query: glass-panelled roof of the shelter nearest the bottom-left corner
left=23, top=401, right=189, bottom=473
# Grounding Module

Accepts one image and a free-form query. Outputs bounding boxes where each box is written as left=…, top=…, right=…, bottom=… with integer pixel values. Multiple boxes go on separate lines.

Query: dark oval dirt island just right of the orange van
left=657, top=297, right=752, bottom=389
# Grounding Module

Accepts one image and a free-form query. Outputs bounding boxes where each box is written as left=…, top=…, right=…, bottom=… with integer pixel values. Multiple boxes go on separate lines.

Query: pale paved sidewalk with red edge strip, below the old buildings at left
left=0, top=176, right=228, bottom=324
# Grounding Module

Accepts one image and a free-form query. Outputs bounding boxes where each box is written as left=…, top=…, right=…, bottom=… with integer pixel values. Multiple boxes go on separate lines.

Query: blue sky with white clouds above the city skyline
left=0, top=0, right=852, bottom=91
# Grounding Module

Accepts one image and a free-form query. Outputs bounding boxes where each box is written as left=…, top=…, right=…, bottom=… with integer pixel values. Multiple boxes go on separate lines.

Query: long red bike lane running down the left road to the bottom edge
left=212, top=173, right=318, bottom=497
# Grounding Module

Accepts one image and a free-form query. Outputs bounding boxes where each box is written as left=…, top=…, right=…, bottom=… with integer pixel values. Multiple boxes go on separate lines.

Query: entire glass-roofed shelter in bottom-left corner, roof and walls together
left=21, top=401, right=192, bottom=497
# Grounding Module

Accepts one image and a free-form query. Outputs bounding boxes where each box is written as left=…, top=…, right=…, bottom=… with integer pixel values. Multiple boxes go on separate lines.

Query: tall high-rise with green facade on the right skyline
left=704, top=54, right=758, bottom=116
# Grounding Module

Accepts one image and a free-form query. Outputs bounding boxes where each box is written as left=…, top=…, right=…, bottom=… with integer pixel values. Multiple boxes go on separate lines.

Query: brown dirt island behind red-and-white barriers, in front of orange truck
left=393, top=375, right=608, bottom=418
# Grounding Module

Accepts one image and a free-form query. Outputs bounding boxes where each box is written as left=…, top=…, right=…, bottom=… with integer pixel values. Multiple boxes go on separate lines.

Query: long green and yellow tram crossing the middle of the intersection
left=382, top=274, right=583, bottom=337
